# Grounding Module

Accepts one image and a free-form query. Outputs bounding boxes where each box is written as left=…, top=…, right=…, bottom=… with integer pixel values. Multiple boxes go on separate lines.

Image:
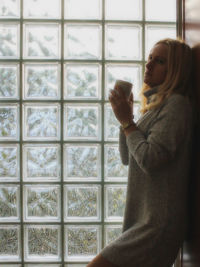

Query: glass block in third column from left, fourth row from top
left=64, top=104, right=101, bottom=140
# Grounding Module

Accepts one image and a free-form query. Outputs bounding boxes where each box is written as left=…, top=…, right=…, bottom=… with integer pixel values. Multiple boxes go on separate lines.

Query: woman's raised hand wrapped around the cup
left=109, top=87, right=133, bottom=124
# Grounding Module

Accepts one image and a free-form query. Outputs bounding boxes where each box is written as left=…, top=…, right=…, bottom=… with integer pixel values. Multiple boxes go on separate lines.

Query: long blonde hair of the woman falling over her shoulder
left=141, top=38, right=193, bottom=114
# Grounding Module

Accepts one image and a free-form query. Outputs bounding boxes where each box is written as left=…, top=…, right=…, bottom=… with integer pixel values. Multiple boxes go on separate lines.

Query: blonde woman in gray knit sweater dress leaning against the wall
left=87, top=39, right=193, bottom=267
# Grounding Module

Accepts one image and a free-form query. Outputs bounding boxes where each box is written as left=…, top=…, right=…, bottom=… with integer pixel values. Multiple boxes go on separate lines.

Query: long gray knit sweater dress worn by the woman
left=101, top=92, right=193, bottom=267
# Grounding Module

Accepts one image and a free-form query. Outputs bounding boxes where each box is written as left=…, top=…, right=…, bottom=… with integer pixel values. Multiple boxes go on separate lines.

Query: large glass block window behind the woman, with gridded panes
left=0, top=0, right=177, bottom=267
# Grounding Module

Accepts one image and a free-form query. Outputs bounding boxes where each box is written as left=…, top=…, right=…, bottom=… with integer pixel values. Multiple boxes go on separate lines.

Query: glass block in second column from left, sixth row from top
left=23, top=185, right=60, bottom=222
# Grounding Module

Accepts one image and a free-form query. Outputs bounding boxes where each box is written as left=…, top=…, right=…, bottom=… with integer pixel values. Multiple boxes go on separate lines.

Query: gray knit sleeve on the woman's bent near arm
left=126, top=95, right=192, bottom=174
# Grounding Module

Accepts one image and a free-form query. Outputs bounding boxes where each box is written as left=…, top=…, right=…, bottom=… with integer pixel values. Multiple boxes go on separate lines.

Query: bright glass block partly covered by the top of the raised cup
left=105, top=64, right=142, bottom=101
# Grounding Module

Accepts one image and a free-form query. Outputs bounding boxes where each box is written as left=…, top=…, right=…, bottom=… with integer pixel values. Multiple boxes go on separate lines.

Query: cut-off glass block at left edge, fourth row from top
left=0, top=104, right=19, bottom=141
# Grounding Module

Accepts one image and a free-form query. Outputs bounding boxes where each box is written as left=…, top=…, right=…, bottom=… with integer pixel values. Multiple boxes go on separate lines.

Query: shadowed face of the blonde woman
left=144, top=44, right=168, bottom=88
